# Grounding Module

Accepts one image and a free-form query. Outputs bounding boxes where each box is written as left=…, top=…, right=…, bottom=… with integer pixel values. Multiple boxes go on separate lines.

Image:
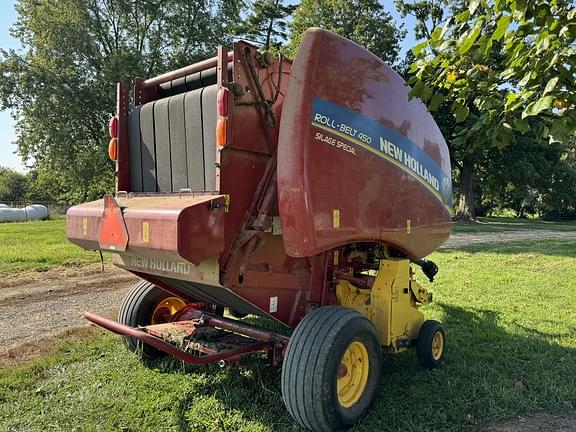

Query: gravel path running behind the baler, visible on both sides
left=0, top=230, right=576, bottom=360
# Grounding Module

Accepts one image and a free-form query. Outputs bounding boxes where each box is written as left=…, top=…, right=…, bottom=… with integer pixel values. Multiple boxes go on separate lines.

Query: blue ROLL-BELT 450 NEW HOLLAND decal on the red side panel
left=312, top=99, right=452, bottom=208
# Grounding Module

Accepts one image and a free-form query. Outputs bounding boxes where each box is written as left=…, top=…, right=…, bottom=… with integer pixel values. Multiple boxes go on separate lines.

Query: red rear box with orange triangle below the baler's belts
left=67, top=193, right=226, bottom=265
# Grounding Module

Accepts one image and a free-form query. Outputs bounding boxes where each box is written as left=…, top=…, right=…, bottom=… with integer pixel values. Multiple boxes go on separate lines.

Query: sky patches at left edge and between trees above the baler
left=0, top=0, right=416, bottom=172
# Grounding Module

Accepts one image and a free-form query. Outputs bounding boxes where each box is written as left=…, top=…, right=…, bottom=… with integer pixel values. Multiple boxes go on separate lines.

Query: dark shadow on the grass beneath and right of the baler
left=150, top=304, right=576, bottom=431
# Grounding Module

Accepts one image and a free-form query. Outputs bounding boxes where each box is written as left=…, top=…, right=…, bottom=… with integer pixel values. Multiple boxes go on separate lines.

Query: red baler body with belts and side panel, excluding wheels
left=67, top=30, right=451, bottom=327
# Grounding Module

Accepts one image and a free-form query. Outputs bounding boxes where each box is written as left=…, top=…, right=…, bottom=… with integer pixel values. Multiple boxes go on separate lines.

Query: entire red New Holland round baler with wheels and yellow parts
left=67, top=29, right=452, bottom=431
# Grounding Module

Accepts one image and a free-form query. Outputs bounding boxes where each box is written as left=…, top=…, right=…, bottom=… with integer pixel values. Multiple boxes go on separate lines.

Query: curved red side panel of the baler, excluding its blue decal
left=278, top=29, right=450, bottom=258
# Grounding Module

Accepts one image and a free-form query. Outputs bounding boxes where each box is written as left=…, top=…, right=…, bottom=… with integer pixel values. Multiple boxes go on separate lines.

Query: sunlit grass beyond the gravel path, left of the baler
left=0, top=217, right=108, bottom=273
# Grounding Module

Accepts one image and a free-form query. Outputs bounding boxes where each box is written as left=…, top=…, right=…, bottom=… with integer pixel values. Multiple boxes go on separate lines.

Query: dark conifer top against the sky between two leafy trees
left=237, top=0, right=296, bottom=49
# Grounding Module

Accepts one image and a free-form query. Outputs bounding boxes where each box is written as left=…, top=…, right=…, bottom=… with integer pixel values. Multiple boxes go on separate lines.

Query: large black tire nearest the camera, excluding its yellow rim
left=281, top=306, right=382, bottom=432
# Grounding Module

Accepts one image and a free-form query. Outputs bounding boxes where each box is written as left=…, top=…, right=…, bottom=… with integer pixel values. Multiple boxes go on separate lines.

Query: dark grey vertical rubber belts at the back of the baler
left=128, top=85, right=218, bottom=192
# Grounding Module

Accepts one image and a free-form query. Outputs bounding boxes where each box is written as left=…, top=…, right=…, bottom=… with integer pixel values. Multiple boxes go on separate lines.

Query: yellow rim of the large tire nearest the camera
left=336, top=342, right=370, bottom=408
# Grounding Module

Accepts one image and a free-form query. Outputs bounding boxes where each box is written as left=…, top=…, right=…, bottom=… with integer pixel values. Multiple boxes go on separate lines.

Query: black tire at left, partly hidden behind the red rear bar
left=118, top=280, right=178, bottom=362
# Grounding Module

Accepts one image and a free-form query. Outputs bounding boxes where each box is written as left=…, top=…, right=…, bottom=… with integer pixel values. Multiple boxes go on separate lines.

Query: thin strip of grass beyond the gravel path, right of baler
left=452, top=217, right=576, bottom=233
